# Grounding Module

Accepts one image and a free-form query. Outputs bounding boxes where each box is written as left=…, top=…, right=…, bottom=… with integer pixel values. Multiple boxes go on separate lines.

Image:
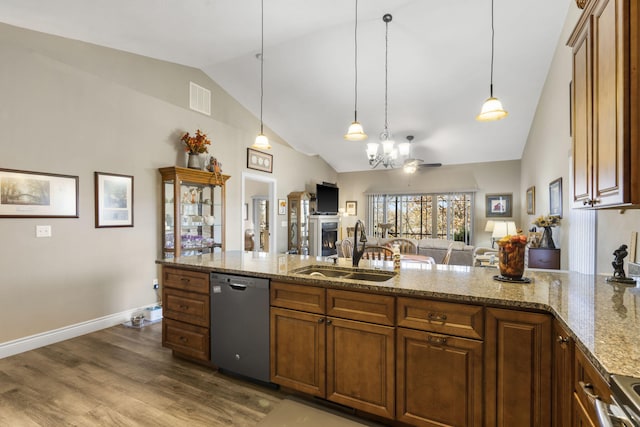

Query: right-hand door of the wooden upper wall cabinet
left=592, top=0, right=630, bottom=206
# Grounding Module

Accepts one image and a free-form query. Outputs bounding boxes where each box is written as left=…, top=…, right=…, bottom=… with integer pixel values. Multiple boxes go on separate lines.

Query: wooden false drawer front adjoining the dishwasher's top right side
left=270, top=281, right=327, bottom=314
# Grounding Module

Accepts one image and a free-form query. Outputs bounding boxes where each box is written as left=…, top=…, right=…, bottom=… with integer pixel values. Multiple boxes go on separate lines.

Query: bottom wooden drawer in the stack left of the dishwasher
left=162, top=318, right=210, bottom=361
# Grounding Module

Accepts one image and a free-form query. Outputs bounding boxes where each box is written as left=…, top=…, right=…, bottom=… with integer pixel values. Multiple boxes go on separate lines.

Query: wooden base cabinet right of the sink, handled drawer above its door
left=396, top=297, right=484, bottom=426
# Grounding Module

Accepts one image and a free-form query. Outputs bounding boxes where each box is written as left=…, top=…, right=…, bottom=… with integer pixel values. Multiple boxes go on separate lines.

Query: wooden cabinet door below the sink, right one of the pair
left=326, top=317, right=395, bottom=419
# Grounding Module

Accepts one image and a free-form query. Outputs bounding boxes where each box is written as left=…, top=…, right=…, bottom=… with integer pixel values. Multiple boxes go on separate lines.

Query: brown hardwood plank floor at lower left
left=0, top=323, right=285, bottom=427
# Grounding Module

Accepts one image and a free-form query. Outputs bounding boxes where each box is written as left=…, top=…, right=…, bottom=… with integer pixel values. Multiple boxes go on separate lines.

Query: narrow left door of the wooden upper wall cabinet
left=572, top=15, right=593, bottom=207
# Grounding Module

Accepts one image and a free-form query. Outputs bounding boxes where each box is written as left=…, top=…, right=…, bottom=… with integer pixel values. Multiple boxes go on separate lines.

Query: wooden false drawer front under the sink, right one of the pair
left=327, top=289, right=395, bottom=326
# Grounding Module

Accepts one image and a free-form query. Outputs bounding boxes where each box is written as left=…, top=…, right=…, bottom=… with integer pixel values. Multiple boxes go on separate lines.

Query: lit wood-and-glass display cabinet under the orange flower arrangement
left=160, top=166, right=230, bottom=258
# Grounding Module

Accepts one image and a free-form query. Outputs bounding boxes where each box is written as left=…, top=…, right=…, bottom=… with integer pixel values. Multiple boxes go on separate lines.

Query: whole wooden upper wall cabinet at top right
left=568, top=0, right=640, bottom=208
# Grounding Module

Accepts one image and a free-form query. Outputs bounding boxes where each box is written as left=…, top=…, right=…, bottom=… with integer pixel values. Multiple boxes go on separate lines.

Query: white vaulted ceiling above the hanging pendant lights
left=0, top=0, right=576, bottom=172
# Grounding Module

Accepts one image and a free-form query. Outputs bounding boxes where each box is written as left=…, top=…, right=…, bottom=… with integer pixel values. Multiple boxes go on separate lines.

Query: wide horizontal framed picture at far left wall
left=0, top=169, right=79, bottom=218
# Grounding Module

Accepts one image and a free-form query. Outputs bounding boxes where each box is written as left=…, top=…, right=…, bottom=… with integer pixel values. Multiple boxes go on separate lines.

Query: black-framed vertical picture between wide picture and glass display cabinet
left=94, top=172, right=133, bottom=228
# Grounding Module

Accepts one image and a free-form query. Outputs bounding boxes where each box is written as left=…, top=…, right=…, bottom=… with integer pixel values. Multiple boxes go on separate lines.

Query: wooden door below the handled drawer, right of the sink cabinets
left=396, top=328, right=482, bottom=427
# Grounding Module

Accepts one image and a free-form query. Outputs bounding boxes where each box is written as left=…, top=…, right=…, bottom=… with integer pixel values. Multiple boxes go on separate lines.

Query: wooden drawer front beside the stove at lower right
left=574, top=349, right=611, bottom=425
